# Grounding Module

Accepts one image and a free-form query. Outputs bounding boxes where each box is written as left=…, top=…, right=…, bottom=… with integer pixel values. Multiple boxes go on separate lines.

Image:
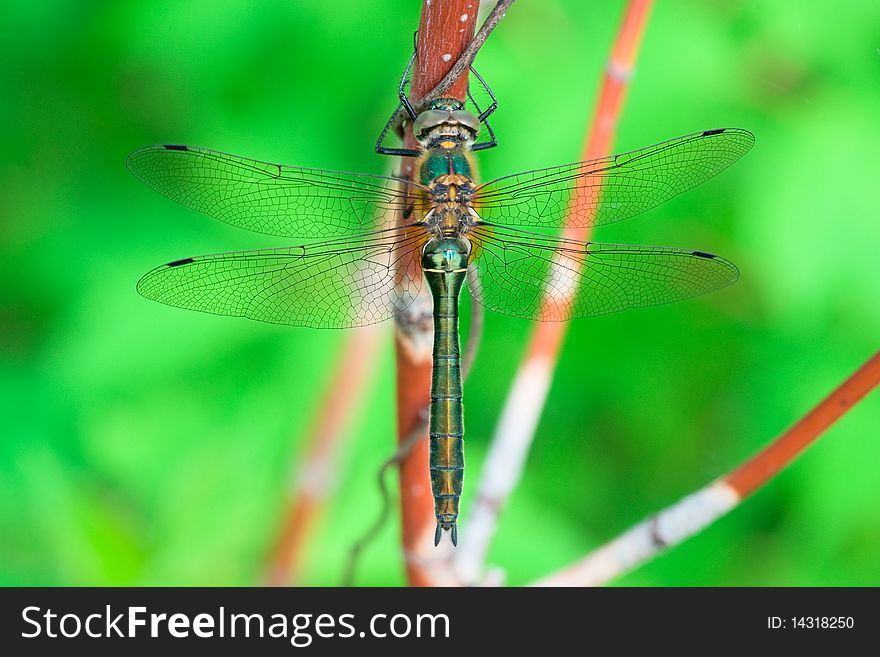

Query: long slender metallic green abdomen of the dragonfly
left=422, top=238, right=469, bottom=544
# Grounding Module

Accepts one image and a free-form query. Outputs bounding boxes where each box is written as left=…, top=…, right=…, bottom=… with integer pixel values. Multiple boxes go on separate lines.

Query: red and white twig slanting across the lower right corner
left=533, top=352, right=880, bottom=586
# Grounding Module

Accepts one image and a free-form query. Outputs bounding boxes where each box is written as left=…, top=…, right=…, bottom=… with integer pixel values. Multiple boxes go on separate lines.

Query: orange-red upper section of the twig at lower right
left=724, top=352, right=880, bottom=497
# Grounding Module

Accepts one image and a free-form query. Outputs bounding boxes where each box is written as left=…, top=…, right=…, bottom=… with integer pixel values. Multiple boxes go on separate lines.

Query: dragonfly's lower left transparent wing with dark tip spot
left=137, top=225, right=427, bottom=328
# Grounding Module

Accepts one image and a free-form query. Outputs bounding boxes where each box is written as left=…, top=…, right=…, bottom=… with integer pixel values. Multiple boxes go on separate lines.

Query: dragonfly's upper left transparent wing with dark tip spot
left=127, top=145, right=428, bottom=239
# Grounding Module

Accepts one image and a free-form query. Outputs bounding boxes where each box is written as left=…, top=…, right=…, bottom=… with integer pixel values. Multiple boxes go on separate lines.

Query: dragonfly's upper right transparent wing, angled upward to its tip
left=473, top=128, right=755, bottom=228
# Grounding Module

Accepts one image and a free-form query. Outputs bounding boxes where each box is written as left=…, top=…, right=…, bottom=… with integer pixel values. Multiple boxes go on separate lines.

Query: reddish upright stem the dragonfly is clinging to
left=395, top=0, right=479, bottom=586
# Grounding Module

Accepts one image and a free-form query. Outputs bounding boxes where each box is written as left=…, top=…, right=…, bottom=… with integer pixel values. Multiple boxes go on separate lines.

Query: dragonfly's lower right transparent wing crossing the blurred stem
left=468, top=225, right=739, bottom=322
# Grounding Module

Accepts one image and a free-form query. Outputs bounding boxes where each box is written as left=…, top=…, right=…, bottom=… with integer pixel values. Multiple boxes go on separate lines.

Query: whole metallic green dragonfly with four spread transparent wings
left=127, top=82, right=754, bottom=545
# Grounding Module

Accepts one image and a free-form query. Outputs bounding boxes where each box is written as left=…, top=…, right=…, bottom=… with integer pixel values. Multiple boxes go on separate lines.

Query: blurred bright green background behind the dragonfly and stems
left=0, top=0, right=880, bottom=585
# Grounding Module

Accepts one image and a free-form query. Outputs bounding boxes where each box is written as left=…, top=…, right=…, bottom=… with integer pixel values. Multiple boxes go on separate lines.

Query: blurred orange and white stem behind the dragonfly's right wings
left=455, top=0, right=652, bottom=583
